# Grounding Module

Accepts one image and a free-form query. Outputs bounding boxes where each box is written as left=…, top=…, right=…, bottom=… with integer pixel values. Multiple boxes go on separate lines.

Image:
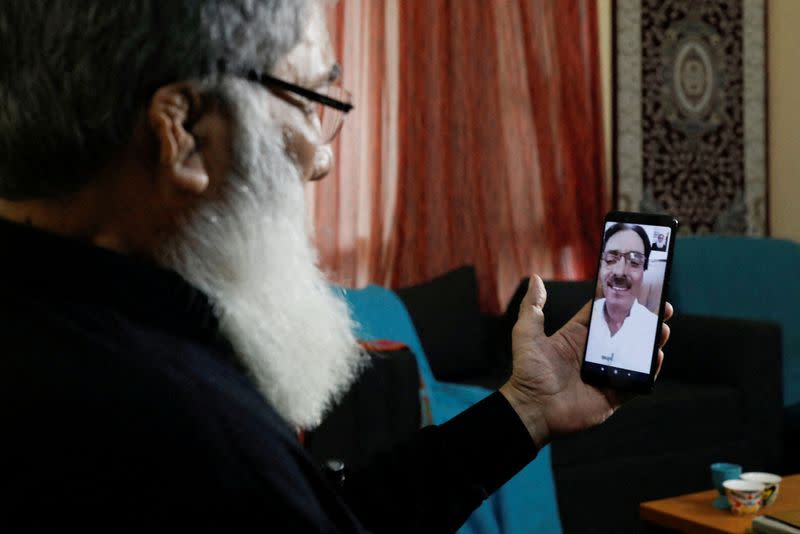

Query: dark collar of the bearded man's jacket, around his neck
left=0, top=219, right=227, bottom=343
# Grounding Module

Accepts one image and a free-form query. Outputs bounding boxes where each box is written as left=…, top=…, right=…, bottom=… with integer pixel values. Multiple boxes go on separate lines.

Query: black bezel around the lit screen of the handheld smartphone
left=581, top=211, right=679, bottom=393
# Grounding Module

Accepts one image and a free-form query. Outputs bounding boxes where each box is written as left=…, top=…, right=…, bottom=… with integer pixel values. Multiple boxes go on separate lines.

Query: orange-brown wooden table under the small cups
left=639, top=474, right=800, bottom=534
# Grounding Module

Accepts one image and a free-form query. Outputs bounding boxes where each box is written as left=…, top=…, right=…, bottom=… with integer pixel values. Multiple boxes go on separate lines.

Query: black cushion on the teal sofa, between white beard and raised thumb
left=395, top=266, right=490, bottom=382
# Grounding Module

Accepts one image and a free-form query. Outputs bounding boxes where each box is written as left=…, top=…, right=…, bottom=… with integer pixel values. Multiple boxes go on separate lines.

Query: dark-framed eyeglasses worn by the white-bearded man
left=247, top=71, right=353, bottom=144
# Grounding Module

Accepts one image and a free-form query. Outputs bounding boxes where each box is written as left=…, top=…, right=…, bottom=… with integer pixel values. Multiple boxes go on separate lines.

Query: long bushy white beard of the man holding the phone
left=162, top=80, right=366, bottom=429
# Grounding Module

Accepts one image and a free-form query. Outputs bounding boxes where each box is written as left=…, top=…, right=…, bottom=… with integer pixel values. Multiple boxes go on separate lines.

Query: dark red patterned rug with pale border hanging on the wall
left=614, top=0, right=768, bottom=235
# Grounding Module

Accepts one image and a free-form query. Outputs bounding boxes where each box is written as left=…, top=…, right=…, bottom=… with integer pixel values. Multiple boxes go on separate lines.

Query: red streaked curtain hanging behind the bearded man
left=309, top=0, right=609, bottom=311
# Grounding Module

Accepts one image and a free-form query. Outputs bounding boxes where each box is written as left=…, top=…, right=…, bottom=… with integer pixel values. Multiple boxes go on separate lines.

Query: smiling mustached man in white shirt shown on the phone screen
left=586, top=223, right=658, bottom=373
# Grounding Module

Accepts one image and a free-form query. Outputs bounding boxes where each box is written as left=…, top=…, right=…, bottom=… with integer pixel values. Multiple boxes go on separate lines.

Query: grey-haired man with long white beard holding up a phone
left=0, top=0, right=668, bottom=532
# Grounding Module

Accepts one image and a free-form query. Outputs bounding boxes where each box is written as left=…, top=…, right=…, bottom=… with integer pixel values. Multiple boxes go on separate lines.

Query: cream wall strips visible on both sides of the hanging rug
left=597, top=0, right=800, bottom=242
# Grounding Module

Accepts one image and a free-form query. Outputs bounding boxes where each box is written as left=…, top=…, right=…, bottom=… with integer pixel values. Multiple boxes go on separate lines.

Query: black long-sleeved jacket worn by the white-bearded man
left=0, top=221, right=536, bottom=532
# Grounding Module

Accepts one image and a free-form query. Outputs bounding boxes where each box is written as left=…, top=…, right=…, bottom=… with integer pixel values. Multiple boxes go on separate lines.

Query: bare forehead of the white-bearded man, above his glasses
left=272, top=2, right=336, bottom=88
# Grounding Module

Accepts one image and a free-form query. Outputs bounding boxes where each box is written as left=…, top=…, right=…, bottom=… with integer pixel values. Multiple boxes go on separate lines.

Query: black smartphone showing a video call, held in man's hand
left=581, top=211, right=678, bottom=393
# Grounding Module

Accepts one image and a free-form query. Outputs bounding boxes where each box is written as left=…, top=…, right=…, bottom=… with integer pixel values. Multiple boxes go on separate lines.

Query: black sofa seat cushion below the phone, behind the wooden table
left=552, top=380, right=755, bottom=533
